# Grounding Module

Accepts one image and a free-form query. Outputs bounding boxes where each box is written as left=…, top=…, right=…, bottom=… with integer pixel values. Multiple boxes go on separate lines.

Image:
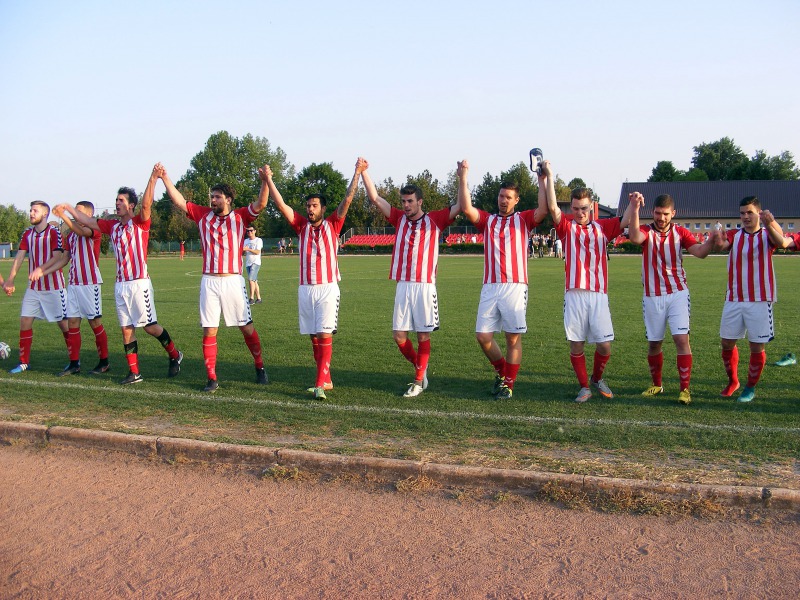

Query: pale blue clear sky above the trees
left=0, top=0, right=800, bottom=216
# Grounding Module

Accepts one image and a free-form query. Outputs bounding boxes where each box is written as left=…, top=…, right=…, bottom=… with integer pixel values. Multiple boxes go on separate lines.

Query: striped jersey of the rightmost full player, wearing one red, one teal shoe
left=725, top=227, right=778, bottom=302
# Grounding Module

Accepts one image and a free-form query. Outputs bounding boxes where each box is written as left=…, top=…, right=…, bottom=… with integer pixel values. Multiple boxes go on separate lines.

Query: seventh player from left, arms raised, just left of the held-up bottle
left=456, top=160, right=555, bottom=400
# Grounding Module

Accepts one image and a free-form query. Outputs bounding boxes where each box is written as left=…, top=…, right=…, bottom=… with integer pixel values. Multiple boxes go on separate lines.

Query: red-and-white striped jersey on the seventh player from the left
left=475, top=209, right=538, bottom=284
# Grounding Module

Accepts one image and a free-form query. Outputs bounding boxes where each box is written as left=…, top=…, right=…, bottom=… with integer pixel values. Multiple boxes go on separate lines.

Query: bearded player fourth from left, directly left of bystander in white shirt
left=153, top=163, right=268, bottom=393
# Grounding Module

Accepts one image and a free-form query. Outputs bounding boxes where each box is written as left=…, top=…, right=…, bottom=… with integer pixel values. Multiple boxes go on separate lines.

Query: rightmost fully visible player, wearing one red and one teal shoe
left=714, top=196, right=790, bottom=402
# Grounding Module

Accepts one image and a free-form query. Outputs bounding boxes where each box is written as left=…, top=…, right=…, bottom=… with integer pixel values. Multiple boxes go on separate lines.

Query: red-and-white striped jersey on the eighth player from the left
left=556, top=215, right=622, bottom=294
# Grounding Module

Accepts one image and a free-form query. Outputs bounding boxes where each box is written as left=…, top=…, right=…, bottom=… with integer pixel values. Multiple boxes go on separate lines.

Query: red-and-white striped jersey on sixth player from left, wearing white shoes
left=389, top=207, right=454, bottom=283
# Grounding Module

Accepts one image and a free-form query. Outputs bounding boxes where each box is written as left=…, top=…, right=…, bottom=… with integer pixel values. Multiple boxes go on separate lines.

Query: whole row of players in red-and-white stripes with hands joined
left=0, top=158, right=800, bottom=405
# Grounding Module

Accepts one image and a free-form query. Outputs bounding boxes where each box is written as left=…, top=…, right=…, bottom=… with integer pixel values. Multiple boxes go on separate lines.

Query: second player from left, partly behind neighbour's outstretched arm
left=29, top=201, right=110, bottom=377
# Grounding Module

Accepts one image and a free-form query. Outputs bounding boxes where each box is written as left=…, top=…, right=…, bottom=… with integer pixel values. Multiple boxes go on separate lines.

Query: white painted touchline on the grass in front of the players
left=0, top=377, right=800, bottom=434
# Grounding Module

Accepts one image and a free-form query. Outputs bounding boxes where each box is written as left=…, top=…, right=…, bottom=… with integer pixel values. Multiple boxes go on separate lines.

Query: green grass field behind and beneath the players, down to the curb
left=0, top=256, right=800, bottom=487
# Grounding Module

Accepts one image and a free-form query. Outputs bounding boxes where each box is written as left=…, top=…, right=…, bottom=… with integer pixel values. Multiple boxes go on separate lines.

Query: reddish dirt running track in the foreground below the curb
left=0, top=446, right=800, bottom=599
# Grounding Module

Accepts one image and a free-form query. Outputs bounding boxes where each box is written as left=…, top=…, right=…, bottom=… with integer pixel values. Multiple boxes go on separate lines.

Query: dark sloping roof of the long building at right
left=617, top=180, right=800, bottom=219
